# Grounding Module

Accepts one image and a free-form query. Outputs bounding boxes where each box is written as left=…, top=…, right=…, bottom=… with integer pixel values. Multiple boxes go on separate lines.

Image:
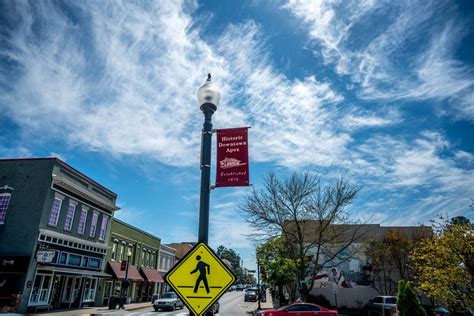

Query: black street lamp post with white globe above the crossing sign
left=197, top=74, right=220, bottom=244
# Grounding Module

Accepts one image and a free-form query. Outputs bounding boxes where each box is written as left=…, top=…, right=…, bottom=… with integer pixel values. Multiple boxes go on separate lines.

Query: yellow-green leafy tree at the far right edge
left=410, top=217, right=474, bottom=307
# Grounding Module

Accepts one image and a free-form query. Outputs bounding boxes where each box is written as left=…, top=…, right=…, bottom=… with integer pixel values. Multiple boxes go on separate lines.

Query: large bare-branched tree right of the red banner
left=241, top=173, right=368, bottom=299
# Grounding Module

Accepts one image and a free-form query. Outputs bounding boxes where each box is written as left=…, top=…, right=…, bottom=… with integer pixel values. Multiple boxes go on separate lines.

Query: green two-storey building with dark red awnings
left=100, top=218, right=164, bottom=305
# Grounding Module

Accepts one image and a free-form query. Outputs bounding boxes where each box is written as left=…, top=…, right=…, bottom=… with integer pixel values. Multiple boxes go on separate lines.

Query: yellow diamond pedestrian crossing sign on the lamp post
left=165, top=243, right=236, bottom=315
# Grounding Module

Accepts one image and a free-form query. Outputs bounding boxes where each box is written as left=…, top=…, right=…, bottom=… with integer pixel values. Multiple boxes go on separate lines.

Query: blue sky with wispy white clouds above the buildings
left=0, top=0, right=474, bottom=268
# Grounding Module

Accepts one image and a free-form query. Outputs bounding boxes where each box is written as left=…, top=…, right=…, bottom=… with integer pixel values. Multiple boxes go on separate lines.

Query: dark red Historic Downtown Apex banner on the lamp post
left=216, top=127, right=250, bottom=187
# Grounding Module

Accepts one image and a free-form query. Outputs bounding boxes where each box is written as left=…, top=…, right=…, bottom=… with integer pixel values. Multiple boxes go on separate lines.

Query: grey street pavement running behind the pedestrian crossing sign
left=95, top=292, right=257, bottom=316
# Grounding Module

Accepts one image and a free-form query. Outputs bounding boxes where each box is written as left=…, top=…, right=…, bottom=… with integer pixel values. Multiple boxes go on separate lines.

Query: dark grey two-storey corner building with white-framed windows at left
left=0, top=158, right=119, bottom=313
